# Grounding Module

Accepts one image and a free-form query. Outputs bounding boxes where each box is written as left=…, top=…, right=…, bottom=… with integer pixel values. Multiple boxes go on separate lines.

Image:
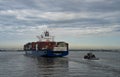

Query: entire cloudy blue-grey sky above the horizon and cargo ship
left=0, top=0, right=120, bottom=49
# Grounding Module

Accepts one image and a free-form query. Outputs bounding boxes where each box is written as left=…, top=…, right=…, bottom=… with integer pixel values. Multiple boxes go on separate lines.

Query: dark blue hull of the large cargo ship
left=25, top=50, right=68, bottom=57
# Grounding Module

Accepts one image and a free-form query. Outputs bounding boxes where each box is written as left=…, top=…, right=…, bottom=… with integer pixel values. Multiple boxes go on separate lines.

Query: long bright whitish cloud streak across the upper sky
left=0, top=10, right=120, bottom=23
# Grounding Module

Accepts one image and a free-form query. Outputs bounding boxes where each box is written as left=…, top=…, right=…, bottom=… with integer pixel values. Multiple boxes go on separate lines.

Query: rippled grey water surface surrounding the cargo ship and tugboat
left=0, top=51, right=120, bottom=77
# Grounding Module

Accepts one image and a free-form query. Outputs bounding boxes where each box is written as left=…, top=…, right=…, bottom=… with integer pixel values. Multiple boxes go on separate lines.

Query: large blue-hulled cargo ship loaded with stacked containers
left=24, top=31, right=69, bottom=57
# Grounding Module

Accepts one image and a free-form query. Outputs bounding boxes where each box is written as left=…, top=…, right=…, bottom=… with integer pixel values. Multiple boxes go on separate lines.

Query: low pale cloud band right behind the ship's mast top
left=0, top=25, right=120, bottom=38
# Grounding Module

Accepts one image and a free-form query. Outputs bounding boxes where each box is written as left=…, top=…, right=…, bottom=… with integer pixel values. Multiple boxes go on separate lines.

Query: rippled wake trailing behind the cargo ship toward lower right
left=70, top=59, right=120, bottom=75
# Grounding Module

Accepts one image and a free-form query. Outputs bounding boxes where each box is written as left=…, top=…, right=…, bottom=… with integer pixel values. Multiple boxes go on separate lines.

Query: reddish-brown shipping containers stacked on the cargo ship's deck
left=24, top=42, right=68, bottom=51
